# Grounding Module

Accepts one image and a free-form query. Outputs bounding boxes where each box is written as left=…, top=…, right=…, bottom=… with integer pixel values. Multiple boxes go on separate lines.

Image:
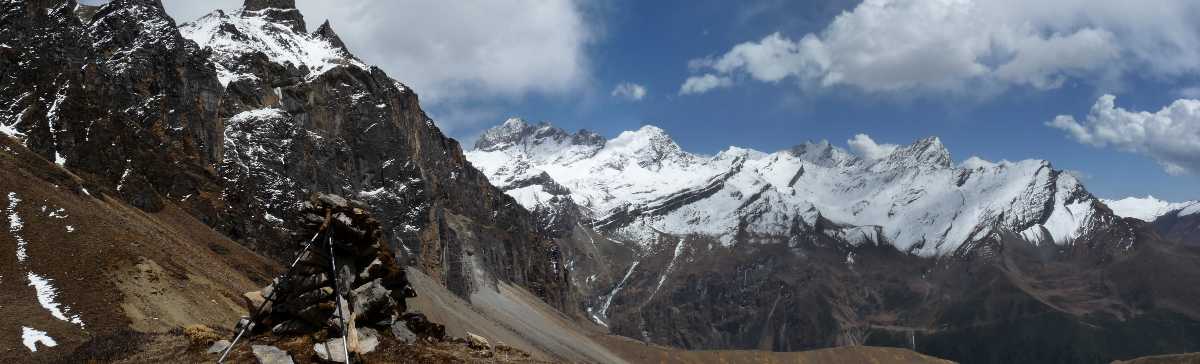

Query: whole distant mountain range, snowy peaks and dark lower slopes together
left=467, top=119, right=1200, bottom=363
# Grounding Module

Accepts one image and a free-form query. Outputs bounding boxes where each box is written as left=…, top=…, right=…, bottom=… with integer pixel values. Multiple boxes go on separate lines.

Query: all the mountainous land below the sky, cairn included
left=0, top=0, right=1200, bottom=363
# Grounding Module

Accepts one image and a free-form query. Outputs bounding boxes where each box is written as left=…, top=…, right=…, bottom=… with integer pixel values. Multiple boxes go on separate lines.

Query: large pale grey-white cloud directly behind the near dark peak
left=156, top=0, right=596, bottom=124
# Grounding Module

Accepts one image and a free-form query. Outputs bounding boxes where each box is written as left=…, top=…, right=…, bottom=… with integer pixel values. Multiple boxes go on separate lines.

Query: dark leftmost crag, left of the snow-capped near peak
left=0, top=0, right=223, bottom=215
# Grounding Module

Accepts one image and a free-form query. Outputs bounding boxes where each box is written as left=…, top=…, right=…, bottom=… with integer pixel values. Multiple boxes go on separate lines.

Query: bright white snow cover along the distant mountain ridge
left=468, top=119, right=1115, bottom=256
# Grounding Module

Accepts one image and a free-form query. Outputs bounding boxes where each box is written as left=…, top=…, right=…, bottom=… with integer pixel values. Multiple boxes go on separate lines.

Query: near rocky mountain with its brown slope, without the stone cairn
left=0, top=0, right=600, bottom=363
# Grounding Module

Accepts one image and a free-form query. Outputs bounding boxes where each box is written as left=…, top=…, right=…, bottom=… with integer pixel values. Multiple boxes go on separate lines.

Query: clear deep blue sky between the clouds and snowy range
left=480, top=1, right=1200, bottom=201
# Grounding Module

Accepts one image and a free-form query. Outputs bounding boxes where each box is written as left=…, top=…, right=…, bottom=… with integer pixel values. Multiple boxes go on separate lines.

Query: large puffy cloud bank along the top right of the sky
left=688, top=0, right=1200, bottom=95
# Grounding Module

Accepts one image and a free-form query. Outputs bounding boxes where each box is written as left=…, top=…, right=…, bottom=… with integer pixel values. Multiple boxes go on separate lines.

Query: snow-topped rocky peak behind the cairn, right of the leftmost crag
left=181, top=1, right=575, bottom=311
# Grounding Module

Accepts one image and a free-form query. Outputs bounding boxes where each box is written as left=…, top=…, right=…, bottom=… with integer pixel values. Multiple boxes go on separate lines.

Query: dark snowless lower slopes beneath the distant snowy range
left=585, top=213, right=1200, bottom=363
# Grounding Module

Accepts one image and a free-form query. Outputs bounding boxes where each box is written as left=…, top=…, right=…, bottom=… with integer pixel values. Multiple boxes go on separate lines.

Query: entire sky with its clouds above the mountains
left=93, top=0, right=1200, bottom=201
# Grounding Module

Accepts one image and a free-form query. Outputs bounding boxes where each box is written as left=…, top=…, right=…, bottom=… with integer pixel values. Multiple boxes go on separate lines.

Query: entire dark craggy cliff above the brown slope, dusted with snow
left=0, top=0, right=575, bottom=311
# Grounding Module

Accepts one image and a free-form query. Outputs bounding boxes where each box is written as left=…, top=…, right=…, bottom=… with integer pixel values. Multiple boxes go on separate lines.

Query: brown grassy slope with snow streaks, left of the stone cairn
left=0, top=136, right=280, bottom=363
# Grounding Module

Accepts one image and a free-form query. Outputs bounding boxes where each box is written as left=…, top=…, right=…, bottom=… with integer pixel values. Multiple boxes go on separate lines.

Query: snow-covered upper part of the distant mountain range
left=467, top=119, right=1111, bottom=256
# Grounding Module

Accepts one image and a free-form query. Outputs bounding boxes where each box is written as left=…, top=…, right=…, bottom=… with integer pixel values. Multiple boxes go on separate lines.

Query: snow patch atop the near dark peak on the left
left=179, top=0, right=368, bottom=84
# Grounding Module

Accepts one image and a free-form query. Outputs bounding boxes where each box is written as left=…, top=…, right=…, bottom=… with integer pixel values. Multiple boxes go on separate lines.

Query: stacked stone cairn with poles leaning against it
left=237, top=195, right=424, bottom=362
